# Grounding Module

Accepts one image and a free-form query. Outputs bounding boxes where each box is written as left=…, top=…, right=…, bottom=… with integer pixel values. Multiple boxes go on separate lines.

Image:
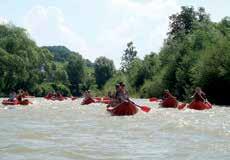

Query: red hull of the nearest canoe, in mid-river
left=107, top=102, right=138, bottom=116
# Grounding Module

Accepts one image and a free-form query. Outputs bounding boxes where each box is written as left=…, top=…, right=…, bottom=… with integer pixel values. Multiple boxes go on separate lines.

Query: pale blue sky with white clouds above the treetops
left=0, top=0, right=230, bottom=67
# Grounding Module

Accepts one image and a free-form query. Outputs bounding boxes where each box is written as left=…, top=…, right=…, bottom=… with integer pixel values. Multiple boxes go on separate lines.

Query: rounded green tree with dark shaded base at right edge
left=192, top=39, right=230, bottom=105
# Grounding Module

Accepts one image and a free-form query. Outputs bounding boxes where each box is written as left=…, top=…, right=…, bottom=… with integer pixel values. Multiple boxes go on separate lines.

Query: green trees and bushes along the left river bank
left=0, top=24, right=108, bottom=96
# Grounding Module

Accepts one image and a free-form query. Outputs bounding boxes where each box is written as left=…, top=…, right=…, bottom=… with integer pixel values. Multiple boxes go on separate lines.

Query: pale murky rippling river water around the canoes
left=0, top=98, right=230, bottom=160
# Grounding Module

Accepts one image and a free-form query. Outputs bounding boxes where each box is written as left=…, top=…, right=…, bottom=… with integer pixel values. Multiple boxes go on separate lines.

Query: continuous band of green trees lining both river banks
left=0, top=6, right=230, bottom=105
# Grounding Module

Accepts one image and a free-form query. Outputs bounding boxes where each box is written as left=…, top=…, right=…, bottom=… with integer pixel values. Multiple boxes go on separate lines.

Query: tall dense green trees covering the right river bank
left=137, top=7, right=230, bottom=104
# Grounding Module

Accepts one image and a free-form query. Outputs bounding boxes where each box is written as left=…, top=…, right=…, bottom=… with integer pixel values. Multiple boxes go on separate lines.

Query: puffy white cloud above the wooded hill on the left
left=24, top=6, right=88, bottom=53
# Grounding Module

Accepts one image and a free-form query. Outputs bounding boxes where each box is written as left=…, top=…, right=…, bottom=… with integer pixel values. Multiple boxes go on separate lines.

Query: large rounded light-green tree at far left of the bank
left=0, top=24, right=52, bottom=94
